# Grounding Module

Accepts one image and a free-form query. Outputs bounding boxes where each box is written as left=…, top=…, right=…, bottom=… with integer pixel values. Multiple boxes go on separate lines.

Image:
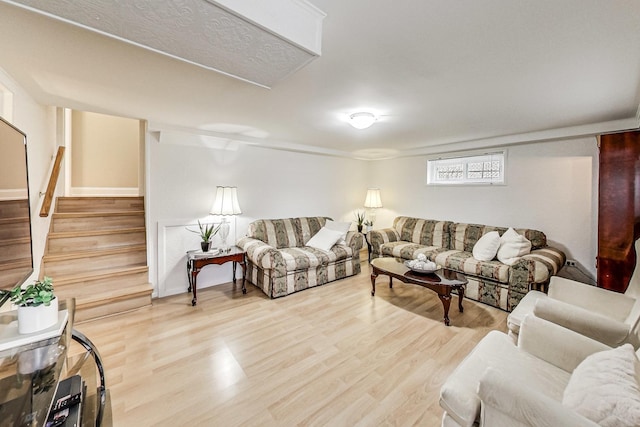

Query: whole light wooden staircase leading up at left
left=41, top=197, right=153, bottom=322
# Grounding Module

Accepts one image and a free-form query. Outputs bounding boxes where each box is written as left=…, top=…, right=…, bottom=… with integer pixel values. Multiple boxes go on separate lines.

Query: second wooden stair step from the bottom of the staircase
left=53, top=265, right=149, bottom=292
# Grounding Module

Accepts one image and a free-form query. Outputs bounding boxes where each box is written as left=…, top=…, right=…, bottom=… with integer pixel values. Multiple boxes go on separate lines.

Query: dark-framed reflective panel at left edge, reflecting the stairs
left=0, top=117, right=33, bottom=305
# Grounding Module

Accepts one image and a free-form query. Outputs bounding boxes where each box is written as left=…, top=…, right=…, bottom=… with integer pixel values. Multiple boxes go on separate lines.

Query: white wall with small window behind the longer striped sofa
left=368, top=138, right=598, bottom=277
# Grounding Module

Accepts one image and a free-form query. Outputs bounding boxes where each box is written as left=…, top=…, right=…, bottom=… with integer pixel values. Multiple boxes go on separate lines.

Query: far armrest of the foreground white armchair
left=518, top=314, right=611, bottom=372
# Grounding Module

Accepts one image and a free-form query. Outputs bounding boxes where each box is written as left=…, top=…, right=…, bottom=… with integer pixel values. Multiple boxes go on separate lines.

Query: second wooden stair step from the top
left=51, top=211, right=145, bottom=233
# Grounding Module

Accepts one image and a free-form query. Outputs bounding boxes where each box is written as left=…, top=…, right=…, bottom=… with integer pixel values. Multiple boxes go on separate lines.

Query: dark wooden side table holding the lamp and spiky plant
left=187, top=246, right=247, bottom=306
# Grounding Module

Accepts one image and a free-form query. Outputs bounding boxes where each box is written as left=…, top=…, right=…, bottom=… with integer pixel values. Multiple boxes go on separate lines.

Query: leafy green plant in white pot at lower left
left=11, top=277, right=58, bottom=334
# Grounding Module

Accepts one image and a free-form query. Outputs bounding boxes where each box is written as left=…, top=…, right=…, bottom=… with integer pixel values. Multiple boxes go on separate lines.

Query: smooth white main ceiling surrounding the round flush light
left=0, top=0, right=640, bottom=158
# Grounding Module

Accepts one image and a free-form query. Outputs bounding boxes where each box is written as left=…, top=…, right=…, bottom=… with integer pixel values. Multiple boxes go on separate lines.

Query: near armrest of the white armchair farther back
left=533, top=298, right=629, bottom=347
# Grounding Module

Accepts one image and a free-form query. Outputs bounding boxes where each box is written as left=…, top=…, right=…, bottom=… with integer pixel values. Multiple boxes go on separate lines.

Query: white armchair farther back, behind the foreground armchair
left=507, top=272, right=640, bottom=349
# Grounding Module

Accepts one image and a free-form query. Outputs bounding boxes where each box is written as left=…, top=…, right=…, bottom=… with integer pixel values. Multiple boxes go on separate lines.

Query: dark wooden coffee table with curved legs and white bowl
left=371, top=258, right=467, bottom=326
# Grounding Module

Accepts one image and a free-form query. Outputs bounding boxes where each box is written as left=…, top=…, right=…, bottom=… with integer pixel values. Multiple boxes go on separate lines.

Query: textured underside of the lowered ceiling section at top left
left=2, top=0, right=322, bottom=87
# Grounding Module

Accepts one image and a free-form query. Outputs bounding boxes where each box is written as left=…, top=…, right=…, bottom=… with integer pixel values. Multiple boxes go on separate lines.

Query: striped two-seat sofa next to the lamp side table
left=236, top=217, right=364, bottom=298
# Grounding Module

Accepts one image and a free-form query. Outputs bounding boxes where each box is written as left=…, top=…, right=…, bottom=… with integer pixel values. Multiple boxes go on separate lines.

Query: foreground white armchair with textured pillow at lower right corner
left=440, top=316, right=640, bottom=427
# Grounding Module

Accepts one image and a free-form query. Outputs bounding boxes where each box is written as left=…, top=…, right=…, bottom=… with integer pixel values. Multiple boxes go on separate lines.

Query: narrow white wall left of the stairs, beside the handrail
left=0, top=68, right=58, bottom=281
